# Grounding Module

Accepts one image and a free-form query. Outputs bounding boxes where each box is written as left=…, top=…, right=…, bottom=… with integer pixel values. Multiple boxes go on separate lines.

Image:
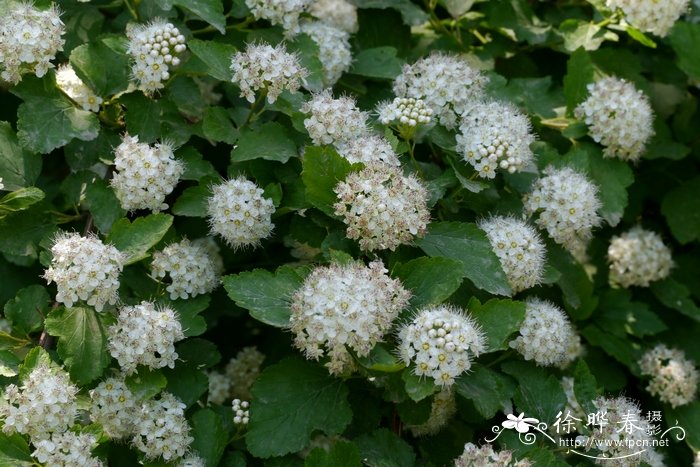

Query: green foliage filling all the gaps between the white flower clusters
left=0, top=0, right=700, bottom=466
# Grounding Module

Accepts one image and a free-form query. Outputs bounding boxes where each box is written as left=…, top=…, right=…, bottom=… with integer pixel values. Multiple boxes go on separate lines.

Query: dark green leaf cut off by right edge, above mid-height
left=661, top=177, right=700, bottom=244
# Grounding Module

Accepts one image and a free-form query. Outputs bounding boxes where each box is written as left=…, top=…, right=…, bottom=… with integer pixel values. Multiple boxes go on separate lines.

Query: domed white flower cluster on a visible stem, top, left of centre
left=231, top=43, right=309, bottom=104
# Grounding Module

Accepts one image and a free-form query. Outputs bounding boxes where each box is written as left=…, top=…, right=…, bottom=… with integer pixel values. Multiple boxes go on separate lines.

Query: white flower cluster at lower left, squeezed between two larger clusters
left=90, top=377, right=140, bottom=439
